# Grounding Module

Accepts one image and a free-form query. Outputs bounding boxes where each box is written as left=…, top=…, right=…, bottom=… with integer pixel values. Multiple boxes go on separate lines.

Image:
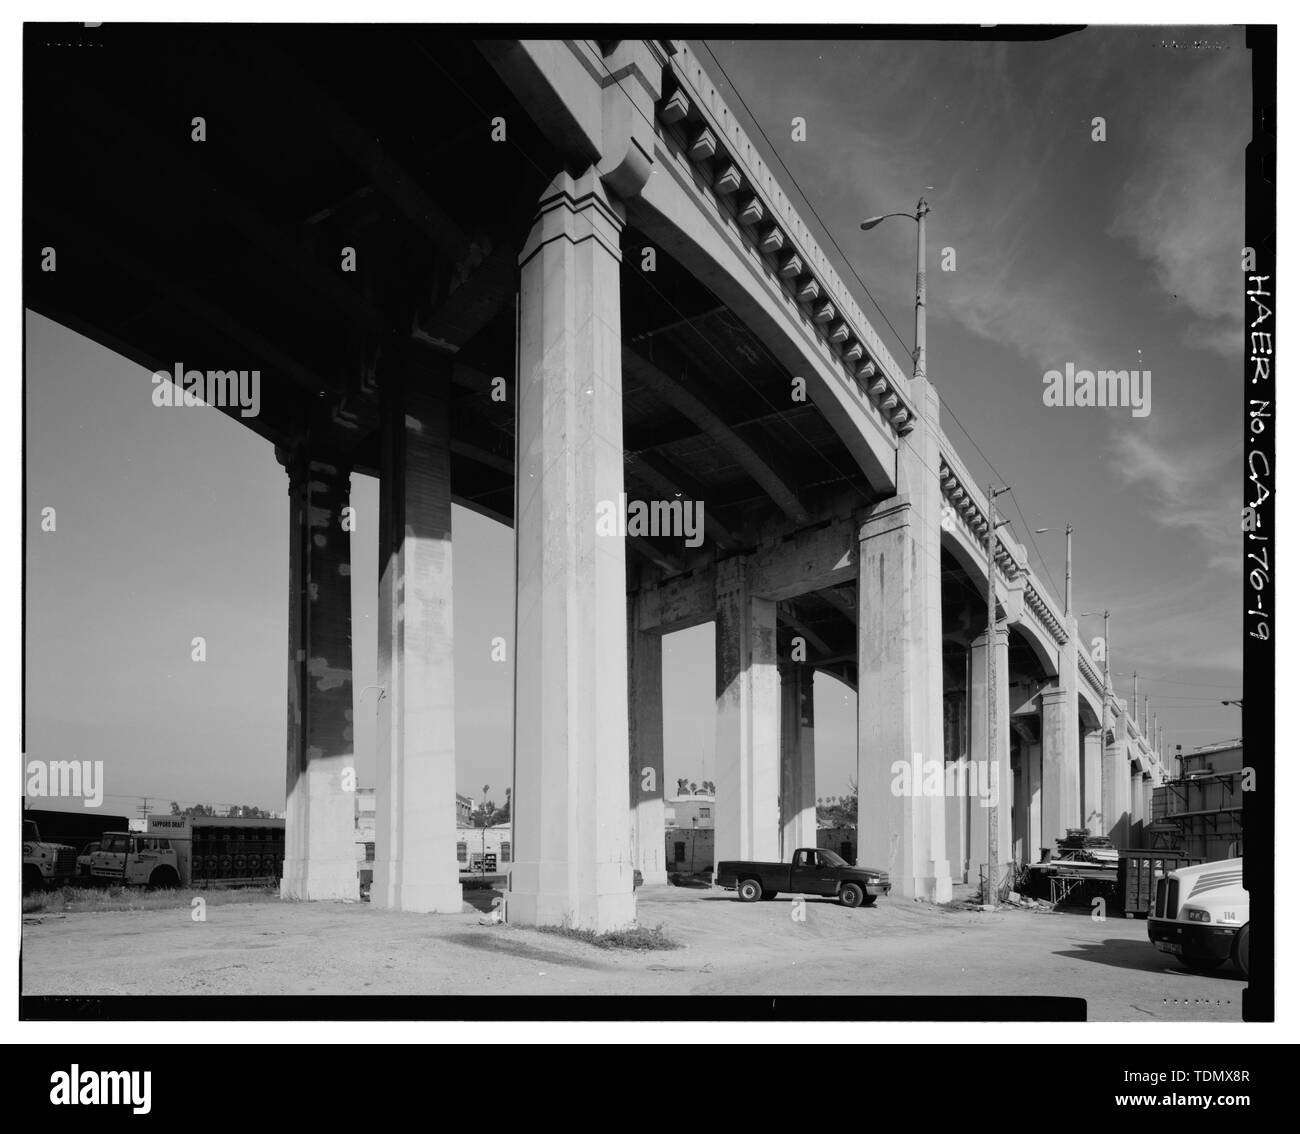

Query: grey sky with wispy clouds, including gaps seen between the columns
left=26, top=29, right=1249, bottom=810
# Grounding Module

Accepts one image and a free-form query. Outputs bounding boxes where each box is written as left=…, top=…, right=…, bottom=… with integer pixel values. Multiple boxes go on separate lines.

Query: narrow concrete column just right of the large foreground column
left=628, top=601, right=668, bottom=886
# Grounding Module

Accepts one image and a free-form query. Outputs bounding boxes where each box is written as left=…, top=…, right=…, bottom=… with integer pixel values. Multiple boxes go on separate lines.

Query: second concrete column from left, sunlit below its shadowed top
left=371, top=360, right=462, bottom=913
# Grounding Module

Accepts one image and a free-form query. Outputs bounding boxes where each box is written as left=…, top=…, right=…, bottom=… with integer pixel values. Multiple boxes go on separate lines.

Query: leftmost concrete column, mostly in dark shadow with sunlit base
left=277, top=447, right=360, bottom=901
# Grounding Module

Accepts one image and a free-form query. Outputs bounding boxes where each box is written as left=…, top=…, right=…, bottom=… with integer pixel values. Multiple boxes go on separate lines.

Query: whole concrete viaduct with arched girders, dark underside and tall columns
left=26, top=27, right=1162, bottom=930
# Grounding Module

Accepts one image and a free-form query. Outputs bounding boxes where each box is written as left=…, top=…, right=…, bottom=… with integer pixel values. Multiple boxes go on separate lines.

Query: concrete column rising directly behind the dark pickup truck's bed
left=714, top=557, right=781, bottom=862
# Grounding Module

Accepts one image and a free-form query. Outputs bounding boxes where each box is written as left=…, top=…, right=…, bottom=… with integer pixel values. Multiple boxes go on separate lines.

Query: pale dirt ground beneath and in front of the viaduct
left=22, top=887, right=1243, bottom=1021
